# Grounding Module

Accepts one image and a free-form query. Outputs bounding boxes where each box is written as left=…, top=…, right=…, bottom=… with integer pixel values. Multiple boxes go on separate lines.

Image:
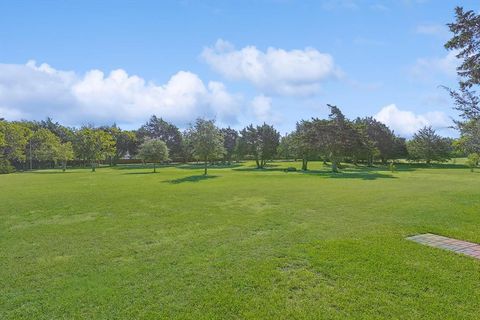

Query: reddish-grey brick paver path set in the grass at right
left=407, top=233, right=480, bottom=259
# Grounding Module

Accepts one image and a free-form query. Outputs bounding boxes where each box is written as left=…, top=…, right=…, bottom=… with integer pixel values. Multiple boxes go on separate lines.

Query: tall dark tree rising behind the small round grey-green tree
left=137, top=115, right=182, bottom=160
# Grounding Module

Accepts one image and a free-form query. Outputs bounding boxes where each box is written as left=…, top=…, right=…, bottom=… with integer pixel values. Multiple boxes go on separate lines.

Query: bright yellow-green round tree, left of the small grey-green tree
left=74, top=127, right=115, bottom=172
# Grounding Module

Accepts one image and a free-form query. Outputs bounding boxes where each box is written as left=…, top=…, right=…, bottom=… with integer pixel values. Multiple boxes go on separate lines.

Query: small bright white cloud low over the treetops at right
left=374, top=104, right=451, bottom=136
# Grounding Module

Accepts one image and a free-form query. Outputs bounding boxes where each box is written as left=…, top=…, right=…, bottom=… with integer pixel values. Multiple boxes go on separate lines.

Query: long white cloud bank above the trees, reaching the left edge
left=0, top=61, right=240, bottom=124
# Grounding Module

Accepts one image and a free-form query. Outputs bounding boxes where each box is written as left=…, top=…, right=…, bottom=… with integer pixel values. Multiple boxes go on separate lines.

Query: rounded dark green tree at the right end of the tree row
left=407, top=127, right=452, bottom=164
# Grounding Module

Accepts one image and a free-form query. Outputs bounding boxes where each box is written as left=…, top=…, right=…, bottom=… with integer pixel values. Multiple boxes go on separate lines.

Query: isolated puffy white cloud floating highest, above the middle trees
left=201, top=39, right=340, bottom=96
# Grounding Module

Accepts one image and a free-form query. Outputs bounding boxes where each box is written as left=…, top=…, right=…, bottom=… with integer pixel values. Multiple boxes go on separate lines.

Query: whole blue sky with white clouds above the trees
left=0, top=0, right=480, bottom=136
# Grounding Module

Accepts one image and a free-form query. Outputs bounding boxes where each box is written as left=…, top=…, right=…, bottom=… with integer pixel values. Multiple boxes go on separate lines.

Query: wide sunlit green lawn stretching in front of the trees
left=0, top=163, right=480, bottom=319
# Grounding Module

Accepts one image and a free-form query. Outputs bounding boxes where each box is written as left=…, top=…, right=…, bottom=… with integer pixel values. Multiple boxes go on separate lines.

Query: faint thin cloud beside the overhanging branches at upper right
left=410, top=51, right=458, bottom=80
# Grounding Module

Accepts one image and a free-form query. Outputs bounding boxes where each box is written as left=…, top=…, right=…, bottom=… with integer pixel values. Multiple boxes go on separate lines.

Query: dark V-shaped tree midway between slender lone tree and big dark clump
left=239, top=123, right=280, bottom=169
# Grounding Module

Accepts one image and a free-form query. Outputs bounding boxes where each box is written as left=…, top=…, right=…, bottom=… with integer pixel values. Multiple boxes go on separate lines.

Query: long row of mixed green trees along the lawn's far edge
left=0, top=105, right=460, bottom=174
